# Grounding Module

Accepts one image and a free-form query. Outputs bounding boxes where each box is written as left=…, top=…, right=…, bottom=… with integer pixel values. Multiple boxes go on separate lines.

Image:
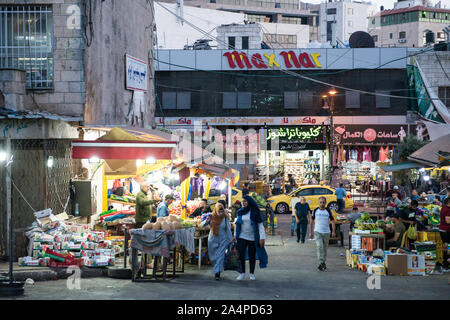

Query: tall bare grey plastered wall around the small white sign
left=84, top=0, right=155, bottom=127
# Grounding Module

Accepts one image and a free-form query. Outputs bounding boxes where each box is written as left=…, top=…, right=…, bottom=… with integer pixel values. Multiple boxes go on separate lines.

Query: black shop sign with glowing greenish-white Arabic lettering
left=267, top=126, right=325, bottom=151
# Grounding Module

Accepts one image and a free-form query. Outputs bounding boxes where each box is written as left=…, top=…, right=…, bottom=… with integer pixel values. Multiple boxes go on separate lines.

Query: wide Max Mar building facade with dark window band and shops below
left=156, top=48, right=428, bottom=205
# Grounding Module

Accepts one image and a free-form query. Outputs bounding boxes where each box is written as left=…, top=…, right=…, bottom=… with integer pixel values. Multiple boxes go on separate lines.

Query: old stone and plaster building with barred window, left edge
left=0, top=0, right=155, bottom=255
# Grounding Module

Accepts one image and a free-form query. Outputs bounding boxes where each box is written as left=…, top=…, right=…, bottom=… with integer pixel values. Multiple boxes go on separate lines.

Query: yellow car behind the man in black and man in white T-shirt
left=267, top=185, right=353, bottom=214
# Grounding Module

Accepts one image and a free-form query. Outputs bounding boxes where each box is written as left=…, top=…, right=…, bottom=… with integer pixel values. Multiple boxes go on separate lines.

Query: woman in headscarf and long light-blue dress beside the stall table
left=202, top=200, right=232, bottom=280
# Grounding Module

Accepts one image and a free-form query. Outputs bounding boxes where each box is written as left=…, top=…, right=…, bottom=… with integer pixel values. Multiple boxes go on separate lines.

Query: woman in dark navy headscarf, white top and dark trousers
left=233, top=196, right=268, bottom=281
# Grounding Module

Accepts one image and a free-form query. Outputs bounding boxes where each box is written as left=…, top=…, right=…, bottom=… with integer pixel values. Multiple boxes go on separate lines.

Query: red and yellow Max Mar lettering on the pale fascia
left=223, top=50, right=322, bottom=70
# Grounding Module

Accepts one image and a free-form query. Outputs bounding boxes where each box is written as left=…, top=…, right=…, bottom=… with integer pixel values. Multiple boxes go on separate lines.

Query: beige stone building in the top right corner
left=369, top=2, right=450, bottom=48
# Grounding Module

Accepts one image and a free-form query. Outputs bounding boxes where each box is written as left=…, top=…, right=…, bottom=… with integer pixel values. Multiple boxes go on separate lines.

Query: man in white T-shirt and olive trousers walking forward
left=311, top=197, right=336, bottom=271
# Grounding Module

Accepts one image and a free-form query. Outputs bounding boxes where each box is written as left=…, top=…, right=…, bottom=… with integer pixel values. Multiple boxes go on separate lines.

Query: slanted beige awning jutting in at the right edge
left=408, top=134, right=450, bottom=167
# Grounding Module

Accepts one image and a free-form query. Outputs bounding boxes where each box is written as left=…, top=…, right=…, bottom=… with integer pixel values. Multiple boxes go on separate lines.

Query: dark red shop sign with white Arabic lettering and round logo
left=334, top=124, right=416, bottom=144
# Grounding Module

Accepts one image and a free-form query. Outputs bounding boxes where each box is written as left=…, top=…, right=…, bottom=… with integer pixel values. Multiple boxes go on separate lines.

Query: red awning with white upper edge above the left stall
left=72, top=141, right=177, bottom=160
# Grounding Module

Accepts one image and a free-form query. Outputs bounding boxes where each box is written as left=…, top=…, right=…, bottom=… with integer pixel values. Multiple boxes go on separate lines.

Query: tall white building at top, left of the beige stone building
left=319, top=0, right=371, bottom=46
